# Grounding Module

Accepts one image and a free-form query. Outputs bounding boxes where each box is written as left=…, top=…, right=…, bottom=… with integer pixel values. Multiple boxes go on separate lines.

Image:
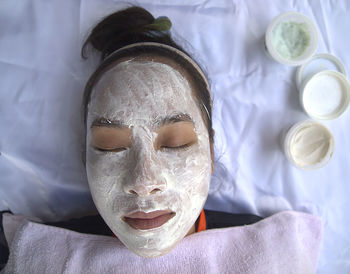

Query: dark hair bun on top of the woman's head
left=82, top=7, right=175, bottom=59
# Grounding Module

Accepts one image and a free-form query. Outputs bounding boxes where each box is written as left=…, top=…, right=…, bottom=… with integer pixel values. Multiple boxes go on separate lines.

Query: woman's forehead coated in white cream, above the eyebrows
left=89, top=57, right=199, bottom=123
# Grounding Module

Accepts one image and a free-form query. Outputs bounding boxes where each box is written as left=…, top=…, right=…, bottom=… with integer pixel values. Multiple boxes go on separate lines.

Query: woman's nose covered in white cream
left=123, top=149, right=167, bottom=197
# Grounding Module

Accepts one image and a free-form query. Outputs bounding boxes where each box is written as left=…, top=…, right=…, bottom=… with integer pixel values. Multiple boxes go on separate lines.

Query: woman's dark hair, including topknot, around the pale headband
left=81, top=6, right=214, bottom=142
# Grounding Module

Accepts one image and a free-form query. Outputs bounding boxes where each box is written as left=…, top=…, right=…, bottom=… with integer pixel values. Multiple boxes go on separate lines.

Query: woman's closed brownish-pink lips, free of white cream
left=122, top=210, right=176, bottom=230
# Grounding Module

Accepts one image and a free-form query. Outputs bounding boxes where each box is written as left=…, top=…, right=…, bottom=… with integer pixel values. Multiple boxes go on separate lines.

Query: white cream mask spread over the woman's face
left=86, top=60, right=211, bottom=257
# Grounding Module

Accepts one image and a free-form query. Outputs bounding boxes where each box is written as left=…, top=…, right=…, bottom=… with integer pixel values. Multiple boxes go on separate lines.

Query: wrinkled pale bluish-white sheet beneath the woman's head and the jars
left=0, top=0, right=350, bottom=273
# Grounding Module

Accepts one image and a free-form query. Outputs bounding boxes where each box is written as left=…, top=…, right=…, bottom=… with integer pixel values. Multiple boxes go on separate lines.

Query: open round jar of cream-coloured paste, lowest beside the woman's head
left=284, top=120, right=335, bottom=170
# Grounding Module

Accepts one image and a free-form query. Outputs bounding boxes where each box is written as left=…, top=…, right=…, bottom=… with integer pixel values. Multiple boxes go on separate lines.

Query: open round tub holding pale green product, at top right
left=265, top=12, right=318, bottom=66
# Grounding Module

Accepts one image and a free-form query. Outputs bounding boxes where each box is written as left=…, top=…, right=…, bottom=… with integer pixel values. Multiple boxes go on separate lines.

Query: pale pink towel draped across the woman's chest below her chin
left=3, top=211, right=322, bottom=274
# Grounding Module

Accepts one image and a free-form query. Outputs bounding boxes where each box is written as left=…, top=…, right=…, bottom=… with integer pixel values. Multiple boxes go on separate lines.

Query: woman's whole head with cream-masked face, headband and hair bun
left=83, top=7, right=213, bottom=257
